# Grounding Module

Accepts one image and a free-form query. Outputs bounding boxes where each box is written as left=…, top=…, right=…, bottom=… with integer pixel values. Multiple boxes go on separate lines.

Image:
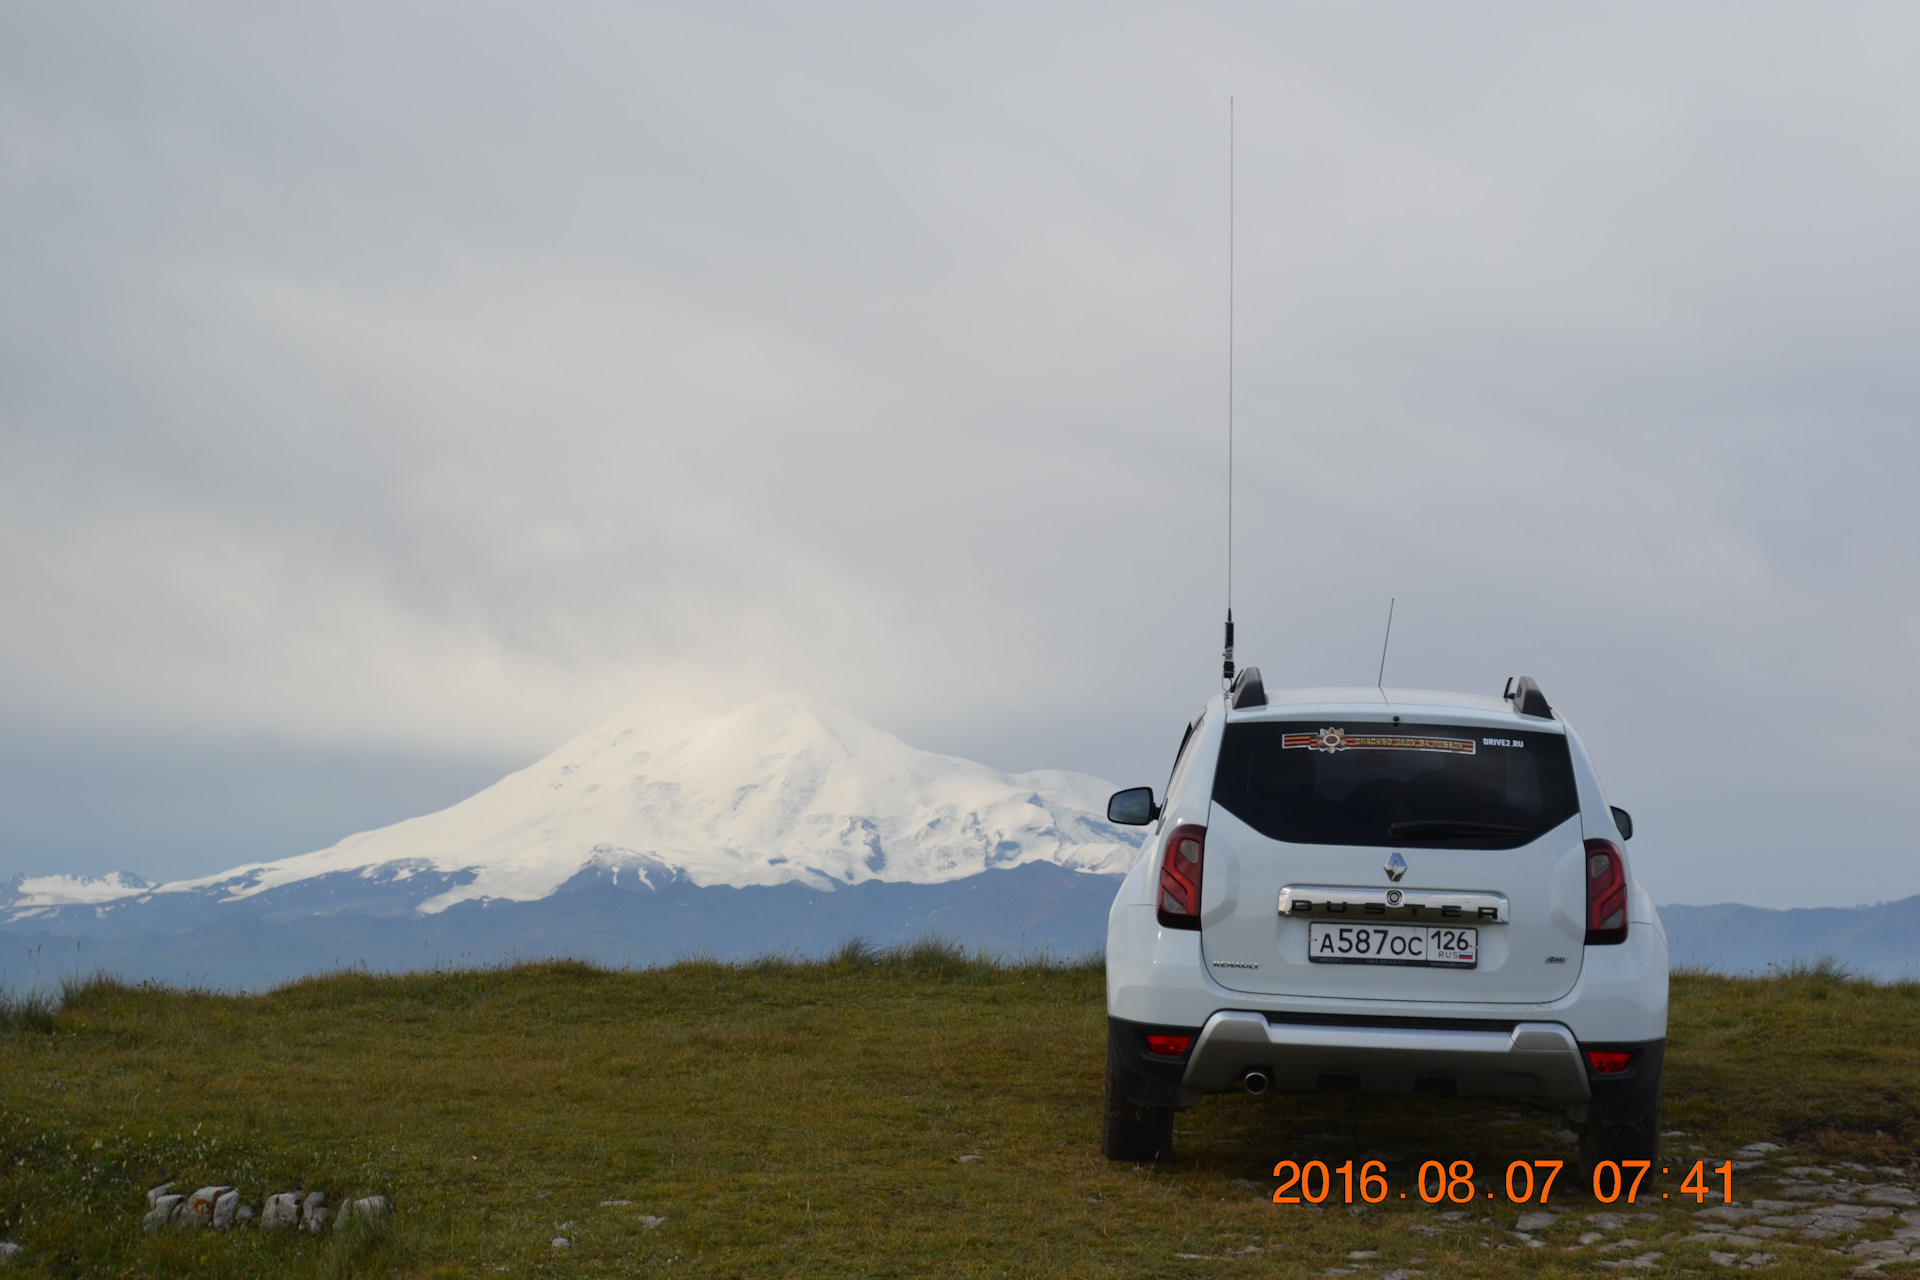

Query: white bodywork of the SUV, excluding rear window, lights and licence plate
left=1106, top=672, right=1667, bottom=1155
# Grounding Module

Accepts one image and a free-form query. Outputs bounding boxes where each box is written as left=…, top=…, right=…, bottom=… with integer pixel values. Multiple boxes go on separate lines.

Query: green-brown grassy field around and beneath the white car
left=0, top=946, right=1920, bottom=1280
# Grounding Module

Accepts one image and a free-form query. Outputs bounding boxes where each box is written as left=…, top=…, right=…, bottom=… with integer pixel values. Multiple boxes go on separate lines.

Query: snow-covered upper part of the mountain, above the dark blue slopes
left=0, top=697, right=1140, bottom=929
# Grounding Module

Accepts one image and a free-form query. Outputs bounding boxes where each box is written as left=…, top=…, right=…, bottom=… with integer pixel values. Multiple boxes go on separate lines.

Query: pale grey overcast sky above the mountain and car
left=0, top=0, right=1920, bottom=906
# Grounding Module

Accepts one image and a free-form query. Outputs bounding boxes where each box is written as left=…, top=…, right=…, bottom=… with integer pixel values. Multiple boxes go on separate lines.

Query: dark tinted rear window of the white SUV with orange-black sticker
left=1213, top=720, right=1580, bottom=848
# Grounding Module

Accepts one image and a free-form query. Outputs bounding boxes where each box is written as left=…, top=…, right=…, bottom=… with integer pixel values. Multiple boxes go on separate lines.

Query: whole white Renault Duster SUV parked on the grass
left=1102, top=668, right=1667, bottom=1165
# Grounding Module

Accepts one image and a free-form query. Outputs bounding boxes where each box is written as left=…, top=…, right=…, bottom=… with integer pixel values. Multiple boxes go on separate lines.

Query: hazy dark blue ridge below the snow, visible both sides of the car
left=0, top=882, right=1920, bottom=988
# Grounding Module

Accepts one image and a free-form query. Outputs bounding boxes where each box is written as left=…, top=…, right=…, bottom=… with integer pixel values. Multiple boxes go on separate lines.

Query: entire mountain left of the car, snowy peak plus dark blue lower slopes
left=0, top=697, right=1144, bottom=986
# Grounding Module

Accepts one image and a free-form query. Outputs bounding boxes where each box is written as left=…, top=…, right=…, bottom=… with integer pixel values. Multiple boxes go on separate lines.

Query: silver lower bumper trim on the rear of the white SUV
left=1183, top=1009, right=1590, bottom=1103
